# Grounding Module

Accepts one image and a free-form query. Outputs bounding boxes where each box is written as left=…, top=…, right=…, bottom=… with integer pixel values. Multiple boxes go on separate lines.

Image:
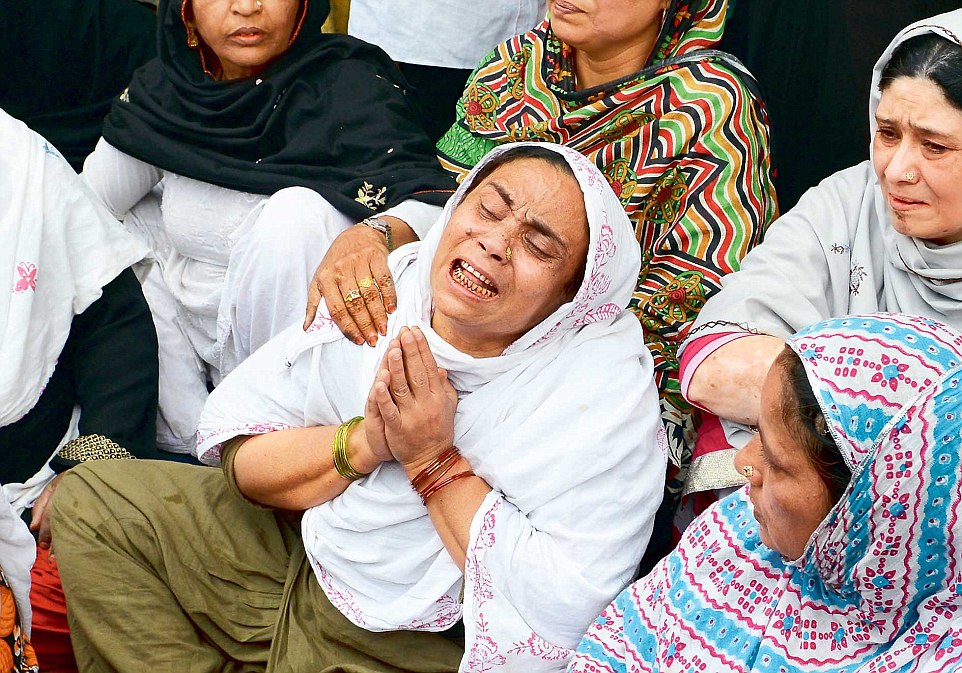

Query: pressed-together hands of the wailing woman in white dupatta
left=364, top=327, right=458, bottom=474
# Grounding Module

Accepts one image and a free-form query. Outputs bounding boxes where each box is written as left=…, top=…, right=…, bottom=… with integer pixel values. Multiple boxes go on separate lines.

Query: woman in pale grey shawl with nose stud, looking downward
left=681, top=10, right=962, bottom=489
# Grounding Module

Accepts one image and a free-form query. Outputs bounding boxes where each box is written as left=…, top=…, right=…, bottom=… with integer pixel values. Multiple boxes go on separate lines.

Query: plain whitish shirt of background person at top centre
left=347, top=0, right=547, bottom=70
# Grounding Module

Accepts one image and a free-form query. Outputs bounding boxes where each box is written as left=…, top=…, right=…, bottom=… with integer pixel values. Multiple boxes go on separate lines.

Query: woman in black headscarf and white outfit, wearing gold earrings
left=84, top=0, right=452, bottom=451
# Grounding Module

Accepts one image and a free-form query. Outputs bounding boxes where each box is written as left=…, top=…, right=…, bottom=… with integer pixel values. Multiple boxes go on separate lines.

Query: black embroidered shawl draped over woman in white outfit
left=104, top=0, right=454, bottom=219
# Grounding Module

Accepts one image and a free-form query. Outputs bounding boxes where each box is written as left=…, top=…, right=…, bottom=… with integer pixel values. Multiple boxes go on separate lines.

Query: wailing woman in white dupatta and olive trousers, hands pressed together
left=54, top=143, right=666, bottom=671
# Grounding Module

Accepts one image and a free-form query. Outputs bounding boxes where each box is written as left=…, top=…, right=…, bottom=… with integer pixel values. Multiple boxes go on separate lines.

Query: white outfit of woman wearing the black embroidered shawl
left=83, top=139, right=358, bottom=453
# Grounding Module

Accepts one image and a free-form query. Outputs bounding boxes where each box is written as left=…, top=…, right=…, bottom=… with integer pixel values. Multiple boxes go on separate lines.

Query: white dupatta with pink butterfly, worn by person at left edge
left=0, top=110, right=146, bottom=635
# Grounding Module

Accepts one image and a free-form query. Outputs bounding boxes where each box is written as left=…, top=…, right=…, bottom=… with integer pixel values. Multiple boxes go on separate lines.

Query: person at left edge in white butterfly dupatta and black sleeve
left=0, top=110, right=157, bottom=670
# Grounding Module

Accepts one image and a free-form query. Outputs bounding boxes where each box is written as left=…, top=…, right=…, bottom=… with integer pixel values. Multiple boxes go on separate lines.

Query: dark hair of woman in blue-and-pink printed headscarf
left=775, top=346, right=852, bottom=503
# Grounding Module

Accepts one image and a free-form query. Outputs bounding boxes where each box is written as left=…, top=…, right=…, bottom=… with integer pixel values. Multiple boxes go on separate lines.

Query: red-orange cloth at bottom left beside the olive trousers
left=30, top=547, right=77, bottom=673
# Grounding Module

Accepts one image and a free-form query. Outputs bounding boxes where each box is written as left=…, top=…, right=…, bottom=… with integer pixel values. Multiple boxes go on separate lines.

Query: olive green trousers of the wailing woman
left=53, top=460, right=463, bottom=673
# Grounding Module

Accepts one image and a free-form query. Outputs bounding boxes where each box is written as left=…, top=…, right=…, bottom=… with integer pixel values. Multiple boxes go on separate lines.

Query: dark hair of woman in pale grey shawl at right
left=879, top=33, right=962, bottom=110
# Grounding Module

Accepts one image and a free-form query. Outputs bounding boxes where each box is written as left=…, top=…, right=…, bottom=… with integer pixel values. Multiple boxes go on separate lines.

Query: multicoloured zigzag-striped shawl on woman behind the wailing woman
left=438, top=0, right=777, bottom=516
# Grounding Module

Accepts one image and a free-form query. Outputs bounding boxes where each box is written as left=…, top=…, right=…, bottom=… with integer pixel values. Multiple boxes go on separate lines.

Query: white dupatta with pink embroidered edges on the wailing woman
left=198, top=143, right=666, bottom=671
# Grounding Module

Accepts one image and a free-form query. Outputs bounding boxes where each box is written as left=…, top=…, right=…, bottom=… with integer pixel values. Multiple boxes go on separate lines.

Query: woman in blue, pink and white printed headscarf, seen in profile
left=569, top=314, right=962, bottom=673
